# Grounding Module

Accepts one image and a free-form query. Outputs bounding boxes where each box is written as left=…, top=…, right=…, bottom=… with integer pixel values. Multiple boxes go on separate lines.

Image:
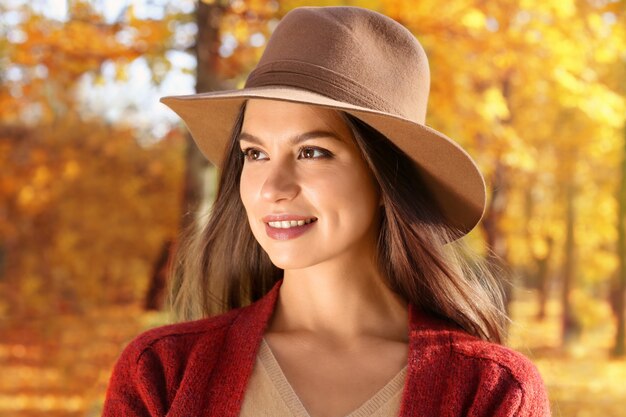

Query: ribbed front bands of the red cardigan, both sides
left=204, top=279, right=450, bottom=417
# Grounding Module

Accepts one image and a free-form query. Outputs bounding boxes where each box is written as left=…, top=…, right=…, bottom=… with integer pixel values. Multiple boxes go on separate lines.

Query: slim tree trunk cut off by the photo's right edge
left=612, top=126, right=626, bottom=357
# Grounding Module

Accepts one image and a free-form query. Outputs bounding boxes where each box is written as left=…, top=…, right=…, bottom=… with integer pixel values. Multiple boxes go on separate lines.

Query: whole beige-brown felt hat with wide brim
left=161, top=7, right=485, bottom=234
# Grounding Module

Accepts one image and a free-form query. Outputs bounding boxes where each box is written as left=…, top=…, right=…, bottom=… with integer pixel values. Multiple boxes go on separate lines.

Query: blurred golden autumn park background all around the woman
left=0, top=0, right=626, bottom=417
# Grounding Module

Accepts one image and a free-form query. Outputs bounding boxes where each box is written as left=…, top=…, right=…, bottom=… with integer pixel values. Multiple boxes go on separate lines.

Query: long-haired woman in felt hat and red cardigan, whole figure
left=104, top=7, right=549, bottom=417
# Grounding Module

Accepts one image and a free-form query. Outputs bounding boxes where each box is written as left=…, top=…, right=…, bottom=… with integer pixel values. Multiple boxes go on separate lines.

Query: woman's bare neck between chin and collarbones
left=269, top=262, right=408, bottom=344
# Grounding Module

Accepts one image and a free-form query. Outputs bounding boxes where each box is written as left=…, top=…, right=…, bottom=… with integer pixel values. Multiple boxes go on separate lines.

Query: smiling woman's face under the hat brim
left=239, top=100, right=379, bottom=269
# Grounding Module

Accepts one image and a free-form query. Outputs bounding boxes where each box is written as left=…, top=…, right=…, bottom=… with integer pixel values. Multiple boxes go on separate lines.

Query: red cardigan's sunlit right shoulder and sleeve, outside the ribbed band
left=412, top=316, right=550, bottom=417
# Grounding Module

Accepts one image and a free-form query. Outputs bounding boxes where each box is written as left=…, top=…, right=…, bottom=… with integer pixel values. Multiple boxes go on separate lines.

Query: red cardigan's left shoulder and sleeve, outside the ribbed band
left=102, top=307, right=245, bottom=417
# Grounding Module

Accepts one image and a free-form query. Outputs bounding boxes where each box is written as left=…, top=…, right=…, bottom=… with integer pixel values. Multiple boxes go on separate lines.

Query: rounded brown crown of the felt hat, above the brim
left=246, top=6, right=430, bottom=124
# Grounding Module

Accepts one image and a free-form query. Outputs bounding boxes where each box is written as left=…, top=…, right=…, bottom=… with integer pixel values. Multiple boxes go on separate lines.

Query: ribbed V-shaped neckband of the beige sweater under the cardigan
left=259, top=337, right=407, bottom=417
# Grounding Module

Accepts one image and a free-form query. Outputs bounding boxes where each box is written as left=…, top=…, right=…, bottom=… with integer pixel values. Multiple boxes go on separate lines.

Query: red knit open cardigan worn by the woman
left=102, top=281, right=550, bottom=417
